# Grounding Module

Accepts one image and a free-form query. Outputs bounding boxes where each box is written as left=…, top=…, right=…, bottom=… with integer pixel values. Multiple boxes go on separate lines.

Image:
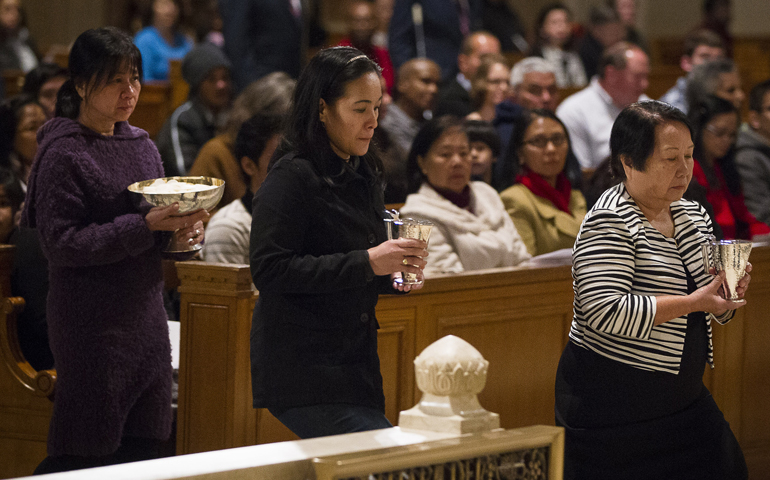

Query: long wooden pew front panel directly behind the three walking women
left=177, top=246, right=770, bottom=472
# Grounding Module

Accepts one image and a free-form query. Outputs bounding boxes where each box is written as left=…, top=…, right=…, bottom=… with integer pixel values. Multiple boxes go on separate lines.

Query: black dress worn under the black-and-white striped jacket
left=556, top=275, right=748, bottom=480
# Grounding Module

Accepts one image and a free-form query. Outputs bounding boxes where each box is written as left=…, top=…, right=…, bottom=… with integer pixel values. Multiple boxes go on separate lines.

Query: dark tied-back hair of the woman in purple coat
left=56, top=27, right=143, bottom=120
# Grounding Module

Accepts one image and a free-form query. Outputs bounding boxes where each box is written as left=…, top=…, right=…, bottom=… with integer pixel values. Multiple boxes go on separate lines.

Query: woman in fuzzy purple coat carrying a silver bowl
left=23, top=28, right=208, bottom=473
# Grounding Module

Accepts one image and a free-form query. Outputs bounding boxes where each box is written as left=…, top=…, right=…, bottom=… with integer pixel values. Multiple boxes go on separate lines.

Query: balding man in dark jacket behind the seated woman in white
left=434, top=31, right=500, bottom=117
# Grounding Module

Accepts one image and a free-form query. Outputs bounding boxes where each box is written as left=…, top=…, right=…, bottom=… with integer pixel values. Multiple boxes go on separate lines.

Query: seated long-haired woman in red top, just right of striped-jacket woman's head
left=689, top=96, right=770, bottom=240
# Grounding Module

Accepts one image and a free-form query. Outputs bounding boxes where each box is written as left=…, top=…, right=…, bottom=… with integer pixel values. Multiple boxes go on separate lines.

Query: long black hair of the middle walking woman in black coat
left=271, top=47, right=382, bottom=182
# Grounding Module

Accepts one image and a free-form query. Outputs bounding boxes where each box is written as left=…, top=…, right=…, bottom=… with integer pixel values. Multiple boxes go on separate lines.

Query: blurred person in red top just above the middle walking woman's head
left=339, top=0, right=396, bottom=95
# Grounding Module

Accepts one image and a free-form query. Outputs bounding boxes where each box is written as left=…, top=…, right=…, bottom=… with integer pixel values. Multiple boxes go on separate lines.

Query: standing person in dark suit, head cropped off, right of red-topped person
left=388, top=0, right=482, bottom=82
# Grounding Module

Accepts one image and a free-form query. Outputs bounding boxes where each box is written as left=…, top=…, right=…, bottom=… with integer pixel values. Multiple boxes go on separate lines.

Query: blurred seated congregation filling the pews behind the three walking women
left=0, top=0, right=770, bottom=367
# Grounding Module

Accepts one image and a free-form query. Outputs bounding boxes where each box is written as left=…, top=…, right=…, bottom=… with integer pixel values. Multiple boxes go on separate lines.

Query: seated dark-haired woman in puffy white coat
left=401, top=117, right=530, bottom=276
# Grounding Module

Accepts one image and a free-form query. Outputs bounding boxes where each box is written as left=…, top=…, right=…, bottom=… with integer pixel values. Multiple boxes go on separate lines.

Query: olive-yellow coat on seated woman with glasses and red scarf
left=500, top=184, right=586, bottom=256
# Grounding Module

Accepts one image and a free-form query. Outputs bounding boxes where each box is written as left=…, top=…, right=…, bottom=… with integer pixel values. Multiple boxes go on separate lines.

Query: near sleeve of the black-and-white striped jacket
left=573, top=209, right=657, bottom=340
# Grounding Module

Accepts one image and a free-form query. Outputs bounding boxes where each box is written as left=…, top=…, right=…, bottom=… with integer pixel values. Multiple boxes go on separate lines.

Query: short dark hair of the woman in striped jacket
left=610, top=100, right=694, bottom=181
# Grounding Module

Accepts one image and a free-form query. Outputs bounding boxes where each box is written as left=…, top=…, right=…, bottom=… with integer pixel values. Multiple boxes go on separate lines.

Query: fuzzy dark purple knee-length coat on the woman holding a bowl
left=23, top=118, right=171, bottom=456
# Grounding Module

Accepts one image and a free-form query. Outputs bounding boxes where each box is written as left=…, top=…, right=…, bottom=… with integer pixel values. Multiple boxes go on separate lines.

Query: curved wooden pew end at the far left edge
left=0, top=245, right=56, bottom=478
